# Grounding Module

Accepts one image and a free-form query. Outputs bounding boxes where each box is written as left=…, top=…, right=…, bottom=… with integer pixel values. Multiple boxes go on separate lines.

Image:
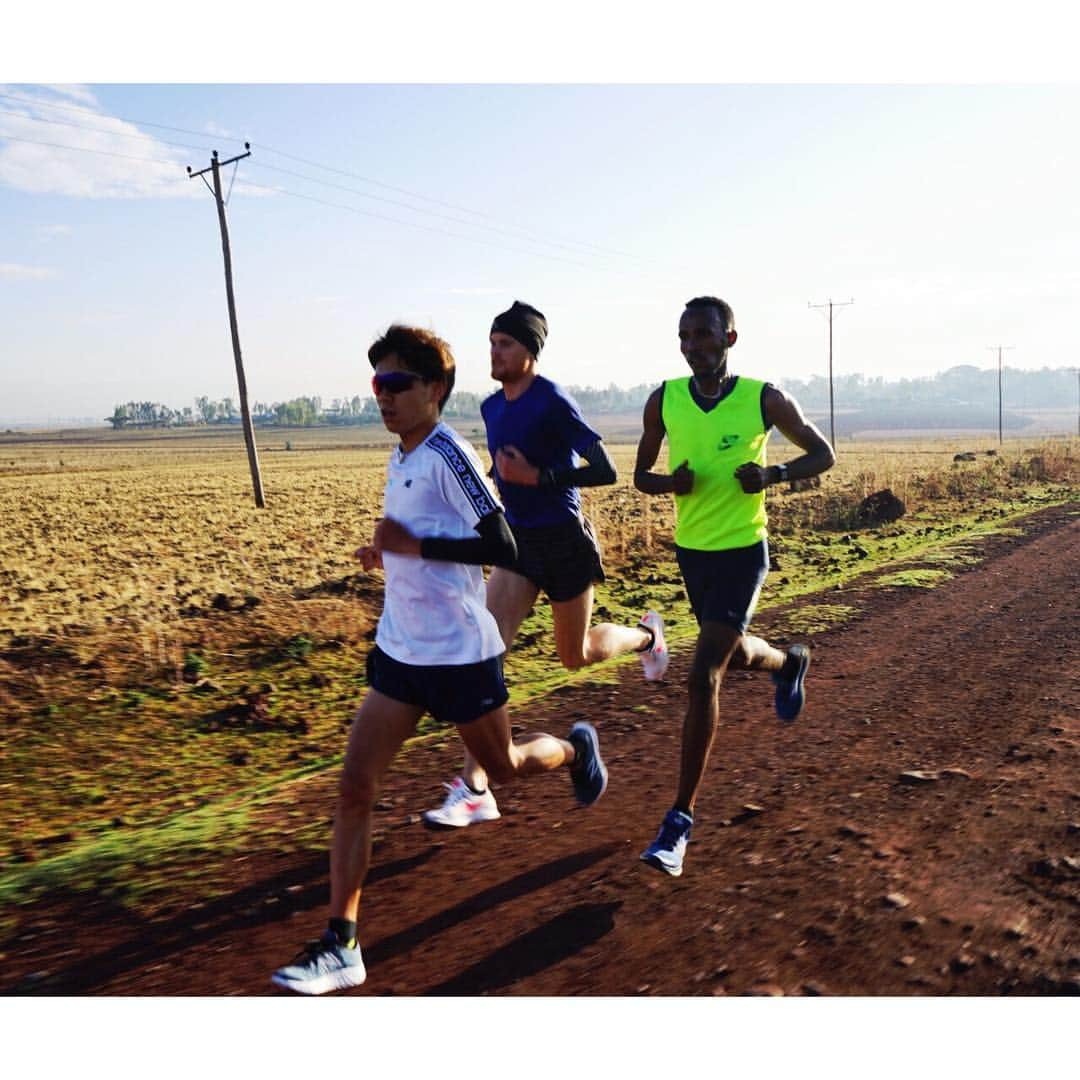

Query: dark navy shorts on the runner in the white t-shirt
left=367, top=645, right=510, bottom=725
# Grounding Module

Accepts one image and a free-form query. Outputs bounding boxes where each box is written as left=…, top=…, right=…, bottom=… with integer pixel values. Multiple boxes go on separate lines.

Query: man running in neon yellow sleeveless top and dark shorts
left=634, top=296, right=836, bottom=877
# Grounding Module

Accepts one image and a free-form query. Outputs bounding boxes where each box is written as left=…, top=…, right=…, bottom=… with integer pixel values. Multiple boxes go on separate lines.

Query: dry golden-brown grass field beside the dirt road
left=0, top=424, right=1080, bottom=901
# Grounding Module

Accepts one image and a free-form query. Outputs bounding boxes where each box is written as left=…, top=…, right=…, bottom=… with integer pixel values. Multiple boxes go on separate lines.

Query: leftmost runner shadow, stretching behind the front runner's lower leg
left=7, top=847, right=442, bottom=996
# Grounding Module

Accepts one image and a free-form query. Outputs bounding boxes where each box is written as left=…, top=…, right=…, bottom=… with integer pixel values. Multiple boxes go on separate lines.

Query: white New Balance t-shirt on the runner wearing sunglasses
left=375, top=422, right=504, bottom=666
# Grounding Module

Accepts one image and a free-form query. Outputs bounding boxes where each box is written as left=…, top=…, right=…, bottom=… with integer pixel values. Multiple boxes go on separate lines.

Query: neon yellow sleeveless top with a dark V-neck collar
left=660, top=375, right=769, bottom=551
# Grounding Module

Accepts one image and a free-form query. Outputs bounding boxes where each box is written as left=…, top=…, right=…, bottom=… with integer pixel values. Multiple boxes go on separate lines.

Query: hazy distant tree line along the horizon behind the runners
left=106, top=364, right=1077, bottom=429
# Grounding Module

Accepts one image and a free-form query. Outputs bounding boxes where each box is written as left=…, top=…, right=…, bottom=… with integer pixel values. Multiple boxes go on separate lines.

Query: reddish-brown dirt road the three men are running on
left=2, top=508, right=1080, bottom=995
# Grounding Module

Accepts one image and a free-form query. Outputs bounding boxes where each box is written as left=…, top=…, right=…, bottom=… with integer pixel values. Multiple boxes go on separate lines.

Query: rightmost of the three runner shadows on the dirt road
left=423, top=901, right=622, bottom=997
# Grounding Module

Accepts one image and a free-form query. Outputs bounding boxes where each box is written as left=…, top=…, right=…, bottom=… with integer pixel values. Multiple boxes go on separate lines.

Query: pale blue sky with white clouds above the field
left=0, top=8, right=1080, bottom=421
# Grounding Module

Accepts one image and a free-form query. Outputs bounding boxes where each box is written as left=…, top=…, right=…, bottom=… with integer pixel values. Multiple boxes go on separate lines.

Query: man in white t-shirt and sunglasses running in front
left=273, top=326, right=607, bottom=994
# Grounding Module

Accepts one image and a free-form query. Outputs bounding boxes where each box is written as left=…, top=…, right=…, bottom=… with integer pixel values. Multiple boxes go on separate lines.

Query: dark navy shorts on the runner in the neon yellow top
left=675, top=540, right=769, bottom=634
